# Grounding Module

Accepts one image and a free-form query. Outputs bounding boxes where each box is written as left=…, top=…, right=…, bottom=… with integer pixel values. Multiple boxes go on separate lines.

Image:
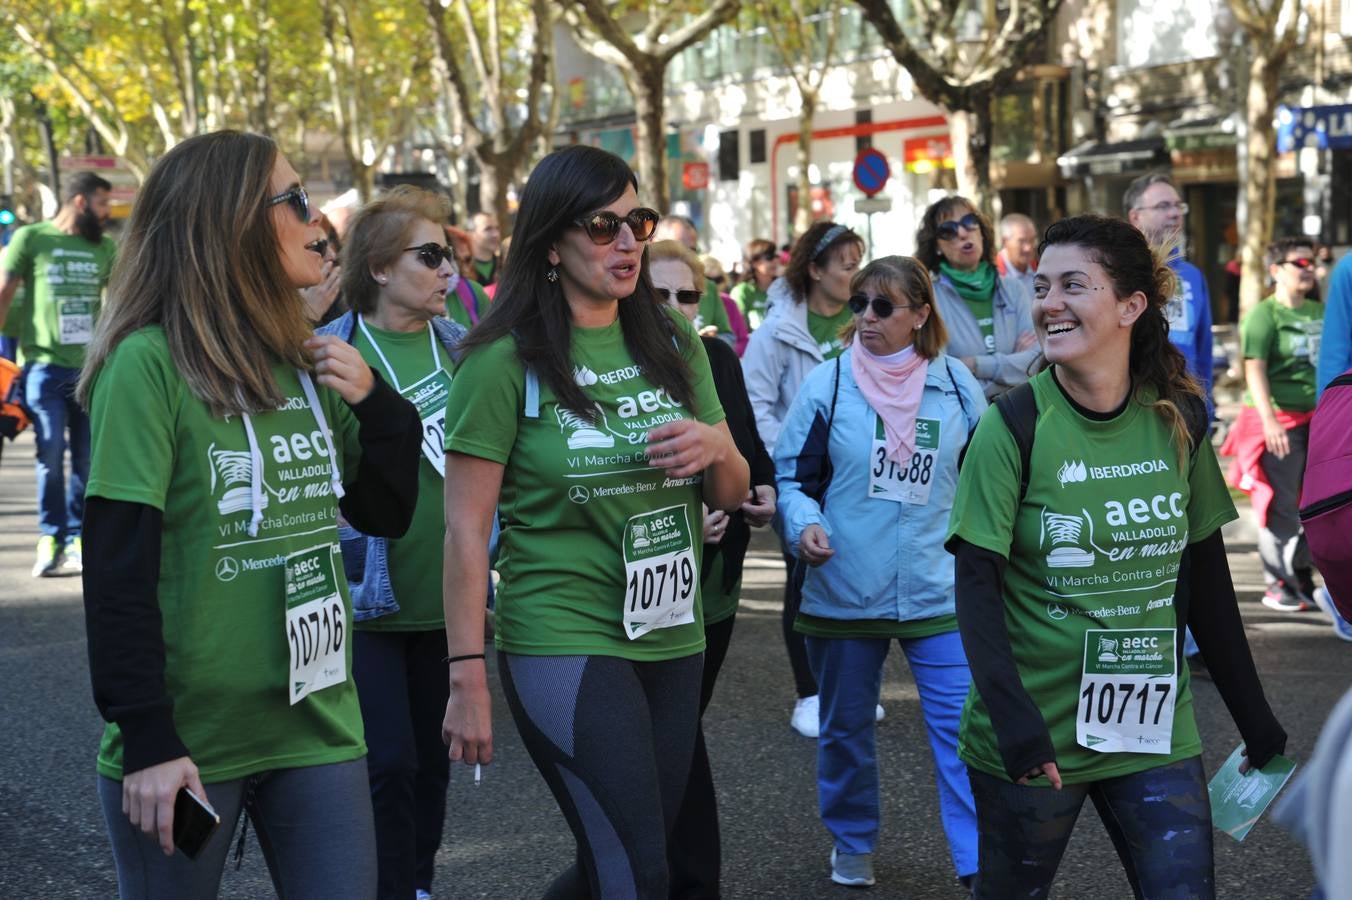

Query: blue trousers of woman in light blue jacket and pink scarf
left=807, top=631, right=976, bottom=876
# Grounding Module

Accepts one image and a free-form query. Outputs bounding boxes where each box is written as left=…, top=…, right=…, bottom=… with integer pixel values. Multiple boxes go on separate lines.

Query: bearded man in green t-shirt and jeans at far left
left=0, top=172, right=116, bottom=577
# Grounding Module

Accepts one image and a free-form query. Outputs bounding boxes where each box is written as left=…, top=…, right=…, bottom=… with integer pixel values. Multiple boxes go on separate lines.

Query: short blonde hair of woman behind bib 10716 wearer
left=342, top=184, right=450, bottom=315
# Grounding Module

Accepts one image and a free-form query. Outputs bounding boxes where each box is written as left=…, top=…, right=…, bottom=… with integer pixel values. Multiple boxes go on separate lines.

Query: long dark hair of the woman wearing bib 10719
left=460, top=145, right=695, bottom=419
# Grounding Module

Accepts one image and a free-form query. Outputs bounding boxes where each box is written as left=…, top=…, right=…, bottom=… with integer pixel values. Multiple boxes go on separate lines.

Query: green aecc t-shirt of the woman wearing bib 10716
left=88, top=326, right=366, bottom=782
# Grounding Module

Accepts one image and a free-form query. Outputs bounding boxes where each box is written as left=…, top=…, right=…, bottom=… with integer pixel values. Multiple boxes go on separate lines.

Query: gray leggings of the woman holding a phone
left=99, top=757, right=376, bottom=900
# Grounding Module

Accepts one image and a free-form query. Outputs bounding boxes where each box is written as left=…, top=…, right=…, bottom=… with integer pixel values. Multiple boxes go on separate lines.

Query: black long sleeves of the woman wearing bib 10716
left=82, top=376, right=422, bottom=774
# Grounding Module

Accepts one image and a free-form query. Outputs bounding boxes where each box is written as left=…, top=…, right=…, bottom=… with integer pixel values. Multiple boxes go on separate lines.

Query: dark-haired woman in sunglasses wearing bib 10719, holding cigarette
left=442, top=146, right=749, bottom=897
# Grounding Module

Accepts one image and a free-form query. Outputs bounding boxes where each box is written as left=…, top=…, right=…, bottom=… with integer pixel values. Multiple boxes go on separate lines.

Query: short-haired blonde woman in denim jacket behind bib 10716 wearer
left=319, top=185, right=465, bottom=900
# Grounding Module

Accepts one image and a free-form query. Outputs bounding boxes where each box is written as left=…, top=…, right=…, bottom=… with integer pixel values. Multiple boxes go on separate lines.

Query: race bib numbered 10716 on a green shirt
left=287, top=543, right=347, bottom=705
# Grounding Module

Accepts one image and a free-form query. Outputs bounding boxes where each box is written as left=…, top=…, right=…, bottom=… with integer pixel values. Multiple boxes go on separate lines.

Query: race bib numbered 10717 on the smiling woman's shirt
left=1075, top=628, right=1178, bottom=754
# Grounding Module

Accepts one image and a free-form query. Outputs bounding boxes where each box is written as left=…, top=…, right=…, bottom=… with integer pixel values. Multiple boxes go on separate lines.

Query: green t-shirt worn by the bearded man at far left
left=0, top=222, right=116, bottom=369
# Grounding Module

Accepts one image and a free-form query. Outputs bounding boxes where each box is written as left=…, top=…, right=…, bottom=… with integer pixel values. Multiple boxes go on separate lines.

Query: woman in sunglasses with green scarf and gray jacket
left=915, top=195, right=1037, bottom=400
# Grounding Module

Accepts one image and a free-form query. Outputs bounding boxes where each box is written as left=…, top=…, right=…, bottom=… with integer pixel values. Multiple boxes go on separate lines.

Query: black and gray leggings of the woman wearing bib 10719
left=499, top=653, right=703, bottom=900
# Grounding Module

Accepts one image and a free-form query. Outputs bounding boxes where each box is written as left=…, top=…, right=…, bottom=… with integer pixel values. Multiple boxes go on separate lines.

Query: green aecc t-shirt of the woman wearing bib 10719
left=446, top=310, right=725, bottom=661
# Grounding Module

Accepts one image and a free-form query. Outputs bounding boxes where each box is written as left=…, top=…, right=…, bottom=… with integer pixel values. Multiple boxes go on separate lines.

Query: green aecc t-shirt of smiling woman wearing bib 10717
left=945, top=370, right=1236, bottom=784
